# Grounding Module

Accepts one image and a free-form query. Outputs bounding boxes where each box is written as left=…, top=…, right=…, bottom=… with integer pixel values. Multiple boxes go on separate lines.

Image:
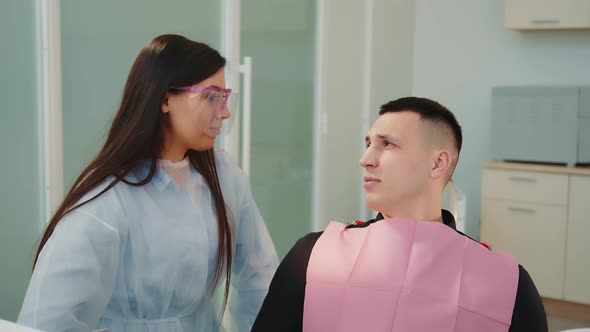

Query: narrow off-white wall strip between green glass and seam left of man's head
left=314, top=0, right=365, bottom=229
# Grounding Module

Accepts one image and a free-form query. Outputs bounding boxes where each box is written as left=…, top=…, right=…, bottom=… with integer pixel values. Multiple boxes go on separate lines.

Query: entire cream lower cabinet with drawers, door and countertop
left=481, top=162, right=590, bottom=304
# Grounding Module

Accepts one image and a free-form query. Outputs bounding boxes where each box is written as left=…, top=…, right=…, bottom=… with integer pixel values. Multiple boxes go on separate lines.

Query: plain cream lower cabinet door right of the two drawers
left=565, top=176, right=590, bottom=303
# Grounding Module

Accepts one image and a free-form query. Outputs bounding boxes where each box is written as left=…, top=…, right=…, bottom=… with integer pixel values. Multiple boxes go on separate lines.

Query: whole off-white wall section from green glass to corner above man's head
left=314, top=0, right=414, bottom=230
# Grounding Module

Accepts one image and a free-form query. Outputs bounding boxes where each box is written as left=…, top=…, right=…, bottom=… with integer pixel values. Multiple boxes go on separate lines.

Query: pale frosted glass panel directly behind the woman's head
left=61, top=0, right=221, bottom=189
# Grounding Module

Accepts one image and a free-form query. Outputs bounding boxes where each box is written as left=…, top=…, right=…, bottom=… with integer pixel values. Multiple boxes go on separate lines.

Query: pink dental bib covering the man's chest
left=303, top=219, right=518, bottom=332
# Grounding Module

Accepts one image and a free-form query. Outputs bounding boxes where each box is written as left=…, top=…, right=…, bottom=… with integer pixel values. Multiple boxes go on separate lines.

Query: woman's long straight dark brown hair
left=33, top=35, right=233, bottom=304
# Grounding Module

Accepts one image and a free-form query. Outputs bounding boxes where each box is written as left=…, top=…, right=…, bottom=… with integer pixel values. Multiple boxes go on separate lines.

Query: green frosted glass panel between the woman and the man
left=241, top=0, right=316, bottom=257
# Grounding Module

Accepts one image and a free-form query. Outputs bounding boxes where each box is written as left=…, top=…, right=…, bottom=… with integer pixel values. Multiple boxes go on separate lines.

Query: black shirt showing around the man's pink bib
left=252, top=210, right=548, bottom=332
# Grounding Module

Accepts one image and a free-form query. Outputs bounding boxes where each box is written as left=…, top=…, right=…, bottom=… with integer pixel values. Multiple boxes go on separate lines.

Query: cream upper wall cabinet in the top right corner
left=504, top=0, right=590, bottom=30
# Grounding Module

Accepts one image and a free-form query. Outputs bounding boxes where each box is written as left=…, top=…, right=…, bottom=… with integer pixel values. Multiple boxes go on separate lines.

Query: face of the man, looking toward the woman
left=360, top=112, right=434, bottom=212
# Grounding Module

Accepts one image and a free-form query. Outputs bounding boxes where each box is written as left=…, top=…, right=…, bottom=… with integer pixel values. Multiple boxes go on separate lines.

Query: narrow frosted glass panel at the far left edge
left=0, top=0, right=42, bottom=321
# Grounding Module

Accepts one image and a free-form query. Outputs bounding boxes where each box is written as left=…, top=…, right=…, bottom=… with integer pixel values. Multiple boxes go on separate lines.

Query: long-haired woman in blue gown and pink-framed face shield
left=18, top=35, right=278, bottom=331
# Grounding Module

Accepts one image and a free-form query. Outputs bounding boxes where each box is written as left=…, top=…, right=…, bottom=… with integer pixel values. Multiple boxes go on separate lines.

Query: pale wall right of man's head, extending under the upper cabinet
left=412, top=0, right=590, bottom=238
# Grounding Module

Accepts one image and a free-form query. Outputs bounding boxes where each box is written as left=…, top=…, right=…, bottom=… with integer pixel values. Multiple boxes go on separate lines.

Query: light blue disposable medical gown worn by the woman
left=18, top=151, right=278, bottom=331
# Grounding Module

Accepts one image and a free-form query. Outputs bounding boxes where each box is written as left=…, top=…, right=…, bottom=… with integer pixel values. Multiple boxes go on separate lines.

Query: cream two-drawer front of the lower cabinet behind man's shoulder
left=481, top=169, right=568, bottom=299
